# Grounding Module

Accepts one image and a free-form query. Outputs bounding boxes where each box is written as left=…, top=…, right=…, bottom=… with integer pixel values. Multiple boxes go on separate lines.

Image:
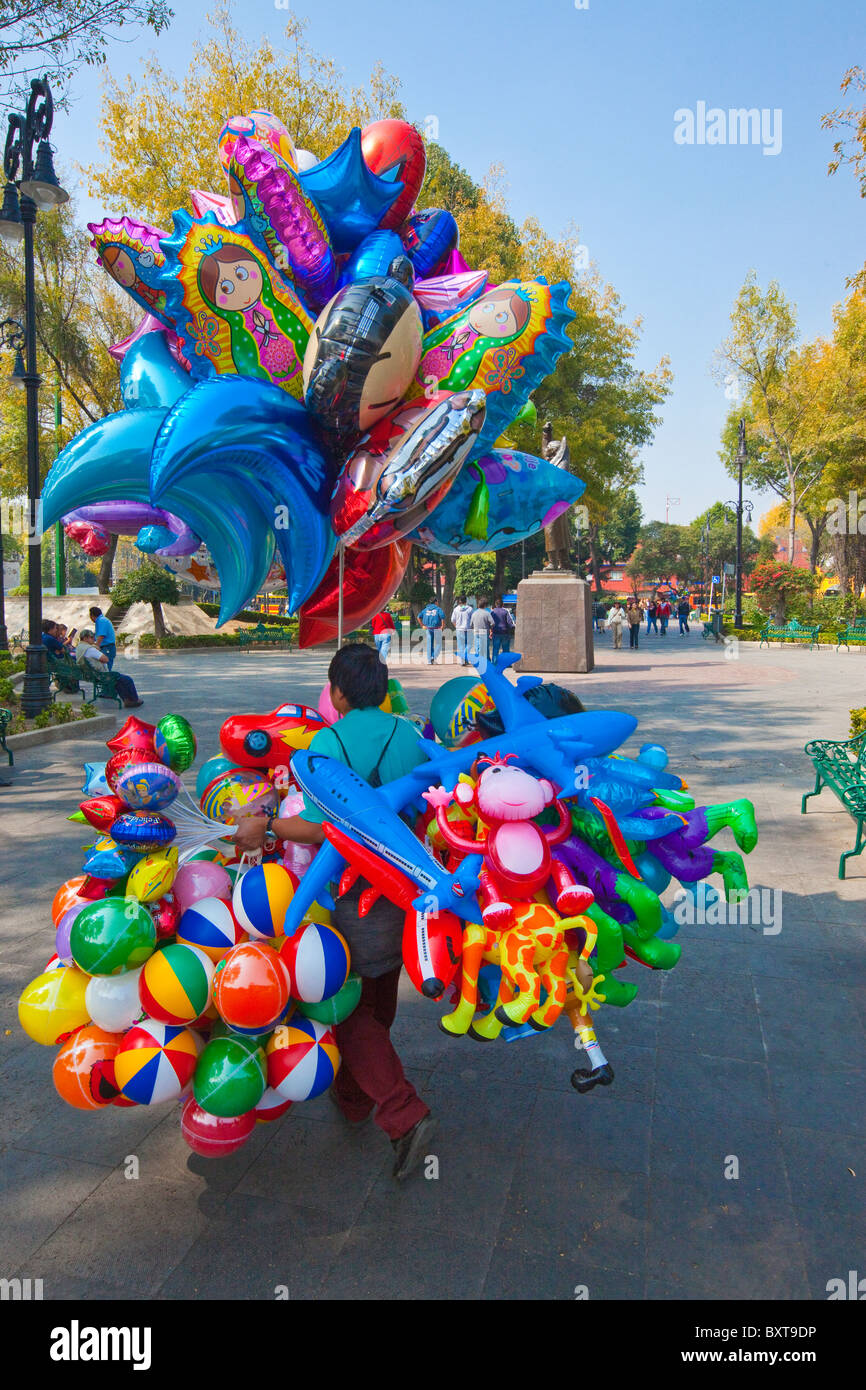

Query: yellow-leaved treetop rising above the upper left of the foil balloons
left=88, top=3, right=403, bottom=228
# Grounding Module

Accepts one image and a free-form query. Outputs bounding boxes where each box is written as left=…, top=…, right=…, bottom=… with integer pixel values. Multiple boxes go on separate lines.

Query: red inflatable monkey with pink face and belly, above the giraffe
left=424, top=753, right=592, bottom=930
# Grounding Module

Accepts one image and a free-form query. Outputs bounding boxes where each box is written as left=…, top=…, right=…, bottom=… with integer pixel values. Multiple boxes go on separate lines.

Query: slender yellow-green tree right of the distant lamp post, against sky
left=717, top=271, right=826, bottom=559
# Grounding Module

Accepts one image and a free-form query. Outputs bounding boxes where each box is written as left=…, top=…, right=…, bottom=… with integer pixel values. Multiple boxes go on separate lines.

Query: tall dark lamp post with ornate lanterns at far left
left=0, top=78, right=70, bottom=717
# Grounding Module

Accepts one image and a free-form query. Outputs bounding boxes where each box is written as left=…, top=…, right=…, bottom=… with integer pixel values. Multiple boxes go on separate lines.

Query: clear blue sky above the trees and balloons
left=53, top=0, right=866, bottom=521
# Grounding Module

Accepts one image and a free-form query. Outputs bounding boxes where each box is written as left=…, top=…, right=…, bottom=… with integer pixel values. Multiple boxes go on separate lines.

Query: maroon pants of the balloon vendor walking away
left=334, top=966, right=430, bottom=1138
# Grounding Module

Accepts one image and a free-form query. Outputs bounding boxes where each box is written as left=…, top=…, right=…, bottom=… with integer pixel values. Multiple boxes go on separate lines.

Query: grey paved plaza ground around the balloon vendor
left=0, top=634, right=866, bottom=1300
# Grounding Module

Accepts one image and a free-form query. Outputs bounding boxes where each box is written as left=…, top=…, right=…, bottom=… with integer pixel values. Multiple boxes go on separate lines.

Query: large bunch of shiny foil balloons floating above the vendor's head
left=43, top=111, right=582, bottom=645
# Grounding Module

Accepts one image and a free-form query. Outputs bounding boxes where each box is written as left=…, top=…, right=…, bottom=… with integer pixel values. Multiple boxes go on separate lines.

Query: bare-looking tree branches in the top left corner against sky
left=0, top=0, right=172, bottom=108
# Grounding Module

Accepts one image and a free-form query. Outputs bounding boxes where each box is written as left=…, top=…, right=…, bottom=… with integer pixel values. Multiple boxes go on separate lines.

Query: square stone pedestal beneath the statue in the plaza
left=514, top=570, right=595, bottom=673
